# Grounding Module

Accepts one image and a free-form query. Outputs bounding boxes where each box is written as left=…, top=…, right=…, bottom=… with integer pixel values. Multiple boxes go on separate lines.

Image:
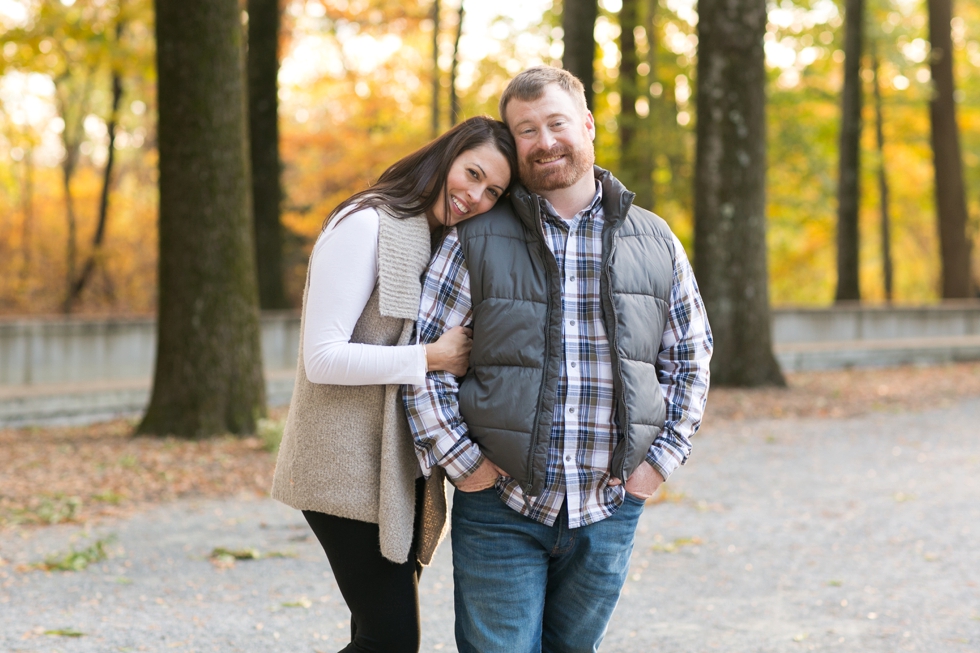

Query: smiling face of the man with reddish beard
left=505, top=84, right=595, bottom=193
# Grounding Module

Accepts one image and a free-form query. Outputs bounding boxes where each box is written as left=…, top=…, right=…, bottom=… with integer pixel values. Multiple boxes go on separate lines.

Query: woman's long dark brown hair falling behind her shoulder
left=323, top=116, right=517, bottom=228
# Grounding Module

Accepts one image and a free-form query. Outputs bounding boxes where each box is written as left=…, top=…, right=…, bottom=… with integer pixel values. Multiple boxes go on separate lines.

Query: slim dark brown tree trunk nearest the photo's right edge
left=928, top=0, right=973, bottom=299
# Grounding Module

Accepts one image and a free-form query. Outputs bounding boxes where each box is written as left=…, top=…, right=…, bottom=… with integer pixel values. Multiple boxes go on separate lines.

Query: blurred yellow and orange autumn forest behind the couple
left=0, top=0, right=980, bottom=315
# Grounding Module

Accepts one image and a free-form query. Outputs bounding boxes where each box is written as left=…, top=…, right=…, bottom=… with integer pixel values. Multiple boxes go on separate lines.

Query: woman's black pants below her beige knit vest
left=303, top=479, right=423, bottom=653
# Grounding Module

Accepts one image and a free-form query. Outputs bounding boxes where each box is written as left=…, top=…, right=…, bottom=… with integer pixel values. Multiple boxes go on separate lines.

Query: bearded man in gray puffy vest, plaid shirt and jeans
left=405, top=66, right=712, bottom=653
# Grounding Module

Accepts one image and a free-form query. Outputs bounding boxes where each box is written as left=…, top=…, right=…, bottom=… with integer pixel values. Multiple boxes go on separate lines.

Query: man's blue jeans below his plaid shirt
left=451, top=488, right=643, bottom=653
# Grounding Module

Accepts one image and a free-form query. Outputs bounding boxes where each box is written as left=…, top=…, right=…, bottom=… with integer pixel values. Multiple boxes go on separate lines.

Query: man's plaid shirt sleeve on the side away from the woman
left=646, top=236, right=714, bottom=480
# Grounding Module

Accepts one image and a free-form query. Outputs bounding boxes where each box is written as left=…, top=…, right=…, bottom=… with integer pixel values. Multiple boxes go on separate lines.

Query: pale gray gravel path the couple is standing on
left=0, top=399, right=980, bottom=653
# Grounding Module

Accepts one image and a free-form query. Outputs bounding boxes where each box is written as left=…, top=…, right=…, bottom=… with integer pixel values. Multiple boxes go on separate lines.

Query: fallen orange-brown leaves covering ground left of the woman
left=0, top=412, right=286, bottom=528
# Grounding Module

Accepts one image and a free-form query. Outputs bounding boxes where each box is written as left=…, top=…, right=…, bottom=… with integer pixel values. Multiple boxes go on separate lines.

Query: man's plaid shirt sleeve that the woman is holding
left=402, top=229, right=486, bottom=483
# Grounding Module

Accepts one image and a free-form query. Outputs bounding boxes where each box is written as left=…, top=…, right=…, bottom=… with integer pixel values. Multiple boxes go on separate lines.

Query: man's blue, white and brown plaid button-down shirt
left=404, top=184, right=712, bottom=528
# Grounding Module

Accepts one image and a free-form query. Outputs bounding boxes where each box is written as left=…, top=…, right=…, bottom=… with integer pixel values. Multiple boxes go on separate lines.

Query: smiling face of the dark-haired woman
left=429, top=143, right=510, bottom=227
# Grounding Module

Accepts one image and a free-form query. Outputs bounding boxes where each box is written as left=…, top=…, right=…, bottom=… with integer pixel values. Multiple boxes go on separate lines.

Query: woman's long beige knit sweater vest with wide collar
left=272, top=210, right=446, bottom=564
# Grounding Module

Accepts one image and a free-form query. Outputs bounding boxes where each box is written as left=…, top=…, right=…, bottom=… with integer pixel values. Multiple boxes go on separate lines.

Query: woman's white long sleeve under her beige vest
left=303, top=208, right=426, bottom=385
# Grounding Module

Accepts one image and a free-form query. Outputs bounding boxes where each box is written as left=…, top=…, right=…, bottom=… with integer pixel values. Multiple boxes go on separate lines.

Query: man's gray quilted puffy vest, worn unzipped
left=457, top=168, right=674, bottom=496
